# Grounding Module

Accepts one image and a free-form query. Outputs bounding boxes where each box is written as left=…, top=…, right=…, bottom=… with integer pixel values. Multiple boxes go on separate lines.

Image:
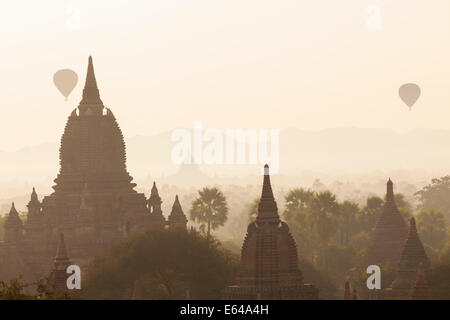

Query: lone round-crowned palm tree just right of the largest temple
left=189, top=187, right=228, bottom=239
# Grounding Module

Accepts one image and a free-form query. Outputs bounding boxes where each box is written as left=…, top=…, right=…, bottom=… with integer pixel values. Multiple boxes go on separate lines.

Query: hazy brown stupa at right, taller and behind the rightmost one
left=364, top=179, right=408, bottom=267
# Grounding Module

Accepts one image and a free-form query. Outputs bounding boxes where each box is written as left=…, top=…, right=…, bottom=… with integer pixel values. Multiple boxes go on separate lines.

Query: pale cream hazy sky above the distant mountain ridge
left=0, top=0, right=450, bottom=150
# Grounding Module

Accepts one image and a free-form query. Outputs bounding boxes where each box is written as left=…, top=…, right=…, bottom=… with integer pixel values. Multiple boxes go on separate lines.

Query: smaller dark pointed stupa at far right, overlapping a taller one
left=391, top=217, right=431, bottom=299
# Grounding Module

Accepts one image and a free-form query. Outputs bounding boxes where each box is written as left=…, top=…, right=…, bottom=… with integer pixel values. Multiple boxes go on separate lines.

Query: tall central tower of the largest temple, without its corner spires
left=38, top=57, right=148, bottom=255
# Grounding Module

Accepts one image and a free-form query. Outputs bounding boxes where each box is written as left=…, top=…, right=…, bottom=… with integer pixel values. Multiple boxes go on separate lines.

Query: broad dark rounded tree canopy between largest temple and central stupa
left=84, top=230, right=239, bottom=299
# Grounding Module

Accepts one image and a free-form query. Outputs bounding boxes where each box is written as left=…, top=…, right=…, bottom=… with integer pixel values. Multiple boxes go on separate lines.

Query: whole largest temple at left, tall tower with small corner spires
left=0, top=57, right=187, bottom=281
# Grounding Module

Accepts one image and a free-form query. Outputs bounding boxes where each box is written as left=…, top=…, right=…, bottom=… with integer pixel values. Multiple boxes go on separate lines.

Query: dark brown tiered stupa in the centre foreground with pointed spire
left=223, top=165, right=318, bottom=299
